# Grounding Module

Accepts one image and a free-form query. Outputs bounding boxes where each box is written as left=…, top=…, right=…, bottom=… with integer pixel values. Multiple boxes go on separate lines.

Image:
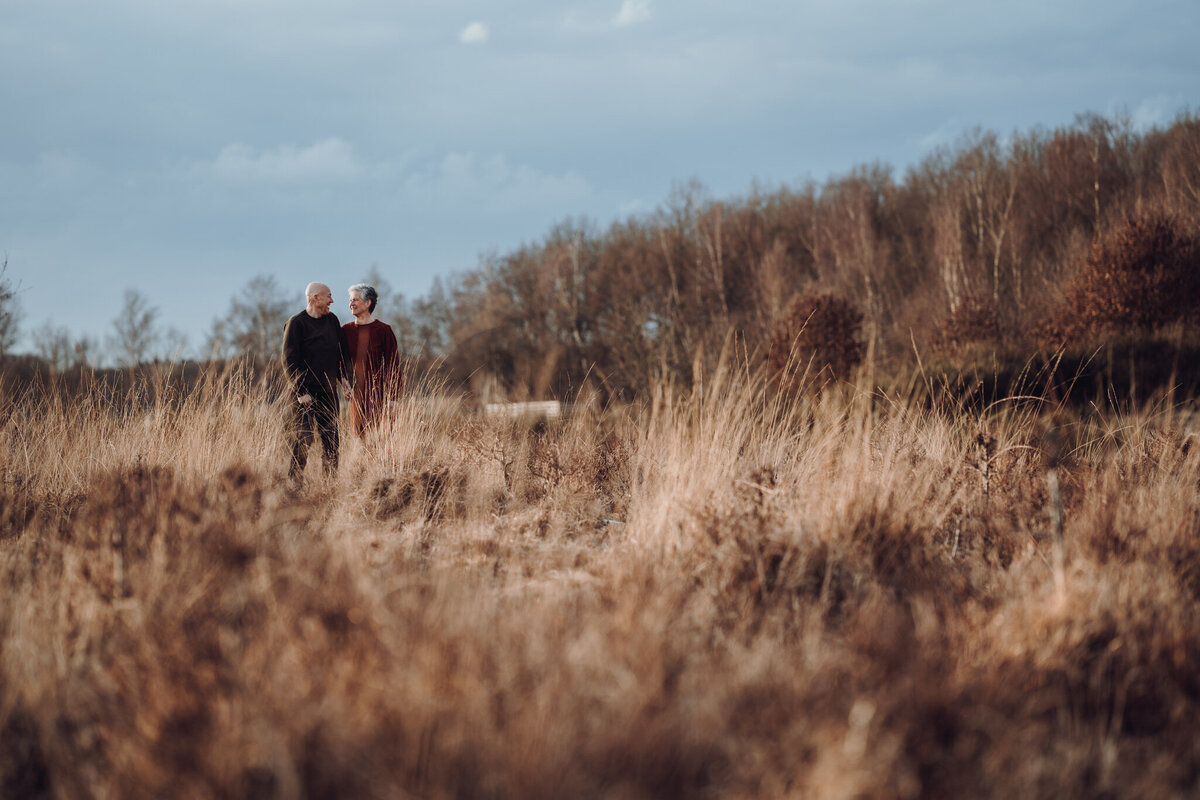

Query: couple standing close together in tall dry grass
left=283, top=283, right=403, bottom=482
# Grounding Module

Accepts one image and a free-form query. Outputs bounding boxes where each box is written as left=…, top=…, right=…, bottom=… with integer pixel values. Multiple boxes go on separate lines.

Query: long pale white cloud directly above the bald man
left=197, top=137, right=364, bottom=182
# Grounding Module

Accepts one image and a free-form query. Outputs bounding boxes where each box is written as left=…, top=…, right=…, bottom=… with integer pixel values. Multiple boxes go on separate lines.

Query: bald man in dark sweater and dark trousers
left=283, top=283, right=350, bottom=483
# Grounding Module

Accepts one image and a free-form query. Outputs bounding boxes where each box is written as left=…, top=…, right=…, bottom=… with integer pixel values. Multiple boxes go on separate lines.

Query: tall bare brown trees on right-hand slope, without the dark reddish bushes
left=424, top=114, right=1200, bottom=397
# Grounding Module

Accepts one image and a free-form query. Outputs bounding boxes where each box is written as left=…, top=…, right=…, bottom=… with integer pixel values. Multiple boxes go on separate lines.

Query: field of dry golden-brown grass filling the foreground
left=0, top=368, right=1200, bottom=799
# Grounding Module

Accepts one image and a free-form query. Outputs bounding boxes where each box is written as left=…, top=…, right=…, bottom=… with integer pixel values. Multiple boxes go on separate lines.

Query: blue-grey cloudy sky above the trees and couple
left=0, top=0, right=1200, bottom=350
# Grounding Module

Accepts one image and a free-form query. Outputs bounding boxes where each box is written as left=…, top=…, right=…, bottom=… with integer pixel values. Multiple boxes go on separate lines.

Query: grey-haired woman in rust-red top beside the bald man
left=342, top=283, right=404, bottom=437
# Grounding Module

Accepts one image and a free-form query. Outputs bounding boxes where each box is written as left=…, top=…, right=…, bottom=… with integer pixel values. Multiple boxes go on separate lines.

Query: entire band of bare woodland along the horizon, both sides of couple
left=0, top=113, right=1200, bottom=399
